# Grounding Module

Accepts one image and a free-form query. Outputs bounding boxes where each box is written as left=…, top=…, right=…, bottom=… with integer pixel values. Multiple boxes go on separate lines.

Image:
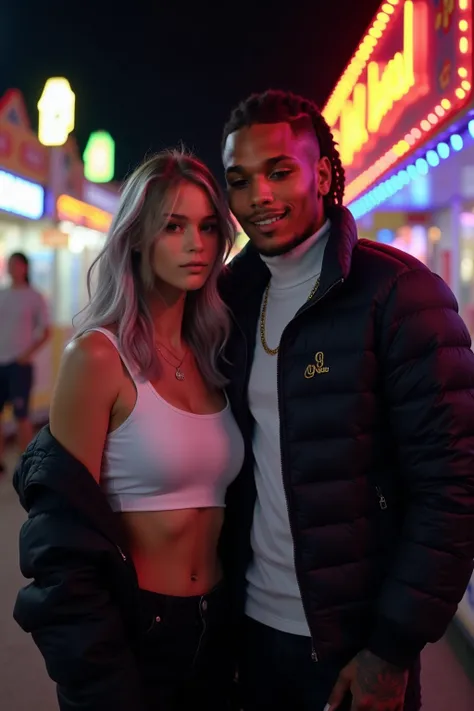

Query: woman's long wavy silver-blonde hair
left=76, top=150, right=235, bottom=387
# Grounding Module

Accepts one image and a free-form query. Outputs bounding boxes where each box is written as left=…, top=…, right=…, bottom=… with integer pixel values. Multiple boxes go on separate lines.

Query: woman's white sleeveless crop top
left=91, top=328, right=244, bottom=511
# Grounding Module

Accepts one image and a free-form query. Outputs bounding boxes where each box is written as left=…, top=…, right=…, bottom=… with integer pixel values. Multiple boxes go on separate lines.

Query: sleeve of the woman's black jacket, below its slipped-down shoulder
left=14, top=512, right=143, bottom=711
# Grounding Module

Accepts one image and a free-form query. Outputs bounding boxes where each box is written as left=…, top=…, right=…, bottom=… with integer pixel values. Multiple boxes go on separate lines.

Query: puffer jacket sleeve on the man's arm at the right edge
left=369, top=267, right=474, bottom=667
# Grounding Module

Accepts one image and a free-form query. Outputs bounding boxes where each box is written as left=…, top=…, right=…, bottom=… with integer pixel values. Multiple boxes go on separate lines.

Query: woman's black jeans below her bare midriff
left=137, top=585, right=232, bottom=711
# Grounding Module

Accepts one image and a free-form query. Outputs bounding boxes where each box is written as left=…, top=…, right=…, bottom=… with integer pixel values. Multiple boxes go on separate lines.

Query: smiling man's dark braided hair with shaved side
left=222, top=89, right=345, bottom=207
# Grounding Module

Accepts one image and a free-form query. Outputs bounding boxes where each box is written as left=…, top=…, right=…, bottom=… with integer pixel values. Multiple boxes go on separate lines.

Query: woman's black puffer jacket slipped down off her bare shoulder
left=14, top=427, right=145, bottom=711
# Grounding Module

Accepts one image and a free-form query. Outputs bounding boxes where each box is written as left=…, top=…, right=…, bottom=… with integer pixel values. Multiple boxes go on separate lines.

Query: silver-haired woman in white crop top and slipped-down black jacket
left=15, top=147, right=244, bottom=711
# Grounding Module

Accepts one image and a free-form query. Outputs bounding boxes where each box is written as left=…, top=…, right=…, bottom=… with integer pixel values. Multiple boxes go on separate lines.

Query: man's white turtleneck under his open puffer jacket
left=246, top=221, right=330, bottom=636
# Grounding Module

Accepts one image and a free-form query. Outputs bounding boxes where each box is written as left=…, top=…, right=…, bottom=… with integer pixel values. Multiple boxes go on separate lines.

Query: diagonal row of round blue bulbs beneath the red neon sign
left=349, top=120, right=474, bottom=220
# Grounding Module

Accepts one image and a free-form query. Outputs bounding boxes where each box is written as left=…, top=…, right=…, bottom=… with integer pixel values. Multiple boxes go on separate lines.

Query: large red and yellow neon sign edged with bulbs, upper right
left=323, top=0, right=473, bottom=203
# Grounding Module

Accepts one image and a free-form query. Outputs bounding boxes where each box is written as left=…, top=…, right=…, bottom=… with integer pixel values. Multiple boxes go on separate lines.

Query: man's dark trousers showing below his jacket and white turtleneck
left=239, top=617, right=420, bottom=711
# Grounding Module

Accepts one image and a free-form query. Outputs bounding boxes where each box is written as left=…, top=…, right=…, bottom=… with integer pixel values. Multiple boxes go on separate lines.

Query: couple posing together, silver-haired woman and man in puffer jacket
left=15, top=91, right=474, bottom=711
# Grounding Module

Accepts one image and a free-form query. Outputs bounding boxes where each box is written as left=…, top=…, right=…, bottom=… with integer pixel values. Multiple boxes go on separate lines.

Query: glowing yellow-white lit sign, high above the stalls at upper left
left=38, top=77, right=76, bottom=146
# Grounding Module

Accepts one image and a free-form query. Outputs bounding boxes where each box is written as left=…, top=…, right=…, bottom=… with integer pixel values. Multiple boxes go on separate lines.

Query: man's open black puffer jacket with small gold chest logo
left=222, top=203, right=474, bottom=666
